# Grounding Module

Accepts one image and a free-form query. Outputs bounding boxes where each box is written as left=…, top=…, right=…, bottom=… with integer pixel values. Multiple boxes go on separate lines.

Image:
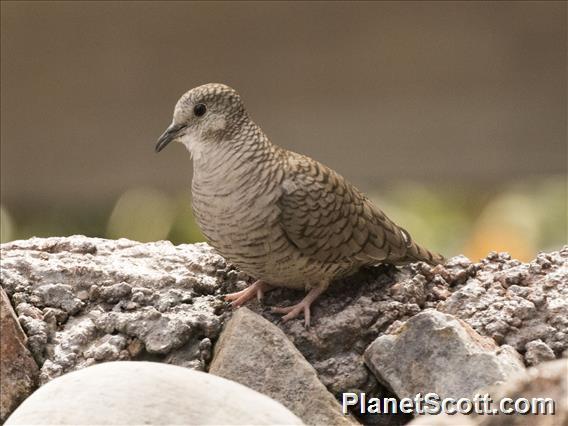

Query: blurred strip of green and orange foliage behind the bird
left=0, top=176, right=568, bottom=261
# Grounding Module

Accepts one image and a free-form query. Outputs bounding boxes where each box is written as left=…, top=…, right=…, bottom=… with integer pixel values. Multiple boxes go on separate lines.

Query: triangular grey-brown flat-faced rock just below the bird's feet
left=209, top=308, right=357, bottom=425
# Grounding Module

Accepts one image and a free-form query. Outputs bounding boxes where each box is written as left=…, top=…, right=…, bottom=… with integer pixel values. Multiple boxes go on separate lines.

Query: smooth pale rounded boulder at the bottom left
left=6, top=362, right=302, bottom=425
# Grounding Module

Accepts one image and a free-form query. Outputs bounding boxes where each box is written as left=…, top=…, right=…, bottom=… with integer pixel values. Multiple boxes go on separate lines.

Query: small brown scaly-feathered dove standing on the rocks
left=155, top=83, right=444, bottom=327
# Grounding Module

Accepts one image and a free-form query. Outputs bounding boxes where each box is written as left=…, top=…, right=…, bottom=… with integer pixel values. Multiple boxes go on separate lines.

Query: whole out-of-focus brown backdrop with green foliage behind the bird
left=0, top=1, right=568, bottom=260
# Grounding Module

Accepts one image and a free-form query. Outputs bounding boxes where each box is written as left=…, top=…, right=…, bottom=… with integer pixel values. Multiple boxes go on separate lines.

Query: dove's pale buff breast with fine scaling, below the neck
left=192, top=158, right=293, bottom=277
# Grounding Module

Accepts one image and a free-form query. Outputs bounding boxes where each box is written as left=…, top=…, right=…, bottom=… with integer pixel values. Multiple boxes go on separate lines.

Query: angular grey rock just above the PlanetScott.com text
left=365, top=309, right=524, bottom=398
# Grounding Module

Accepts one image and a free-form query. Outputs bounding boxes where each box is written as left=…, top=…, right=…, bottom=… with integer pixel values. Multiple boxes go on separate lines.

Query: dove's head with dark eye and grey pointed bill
left=156, top=83, right=246, bottom=153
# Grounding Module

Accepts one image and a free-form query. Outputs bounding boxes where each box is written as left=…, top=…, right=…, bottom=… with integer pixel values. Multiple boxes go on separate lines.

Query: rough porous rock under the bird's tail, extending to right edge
left=250, top=246, right=568, bottom=406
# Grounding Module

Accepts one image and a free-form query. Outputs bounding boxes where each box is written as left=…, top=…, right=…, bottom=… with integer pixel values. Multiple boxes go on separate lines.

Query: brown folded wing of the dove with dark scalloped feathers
left=278, top=154, right=412, bottom=265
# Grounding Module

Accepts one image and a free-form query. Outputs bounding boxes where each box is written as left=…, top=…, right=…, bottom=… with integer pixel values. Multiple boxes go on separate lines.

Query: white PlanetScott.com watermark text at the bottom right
left=342, top=392, right=556, bottom=415
